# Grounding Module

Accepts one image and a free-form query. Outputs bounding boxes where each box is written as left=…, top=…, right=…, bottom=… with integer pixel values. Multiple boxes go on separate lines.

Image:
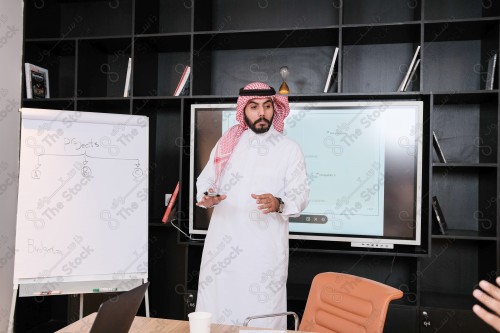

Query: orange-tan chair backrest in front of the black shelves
left=299, top=272, right=403, bottom=333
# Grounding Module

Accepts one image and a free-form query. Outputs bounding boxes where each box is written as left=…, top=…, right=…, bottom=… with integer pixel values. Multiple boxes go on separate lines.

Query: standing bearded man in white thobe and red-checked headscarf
left=196, top=82, right=309, bottom=329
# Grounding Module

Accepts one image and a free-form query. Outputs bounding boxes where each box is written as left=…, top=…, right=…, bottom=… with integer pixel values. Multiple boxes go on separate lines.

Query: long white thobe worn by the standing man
left=196, top=128, right=309, bottom=329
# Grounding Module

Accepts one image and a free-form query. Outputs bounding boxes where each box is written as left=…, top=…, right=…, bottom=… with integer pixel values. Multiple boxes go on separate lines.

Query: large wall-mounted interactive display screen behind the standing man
left=189, top=101, right=423, bottom=248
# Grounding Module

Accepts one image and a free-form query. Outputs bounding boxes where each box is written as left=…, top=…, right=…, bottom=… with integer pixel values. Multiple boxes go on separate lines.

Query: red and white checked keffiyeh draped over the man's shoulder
left=214, top=82, right=290, bottom=185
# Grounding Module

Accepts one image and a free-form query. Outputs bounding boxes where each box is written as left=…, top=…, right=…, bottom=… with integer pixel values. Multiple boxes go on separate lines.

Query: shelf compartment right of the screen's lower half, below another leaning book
left=432, top=168, right=497, bottom=232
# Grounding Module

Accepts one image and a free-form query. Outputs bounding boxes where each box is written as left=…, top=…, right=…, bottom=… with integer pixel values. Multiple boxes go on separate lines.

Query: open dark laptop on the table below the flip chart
left=90, top=282, right=149, bottom=333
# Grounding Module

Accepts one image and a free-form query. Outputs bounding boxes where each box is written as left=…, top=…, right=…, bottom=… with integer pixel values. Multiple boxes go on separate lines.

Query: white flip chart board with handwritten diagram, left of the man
left=14, top=108, right=149, bottom=292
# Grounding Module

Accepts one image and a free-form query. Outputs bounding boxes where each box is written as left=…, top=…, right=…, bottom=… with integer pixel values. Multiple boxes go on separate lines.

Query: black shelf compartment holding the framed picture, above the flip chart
left=23, top=40, right=76, bottom=98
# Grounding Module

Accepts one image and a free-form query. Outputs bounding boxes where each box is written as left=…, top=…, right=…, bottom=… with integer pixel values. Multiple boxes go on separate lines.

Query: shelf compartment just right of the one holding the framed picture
left=76, top=38, right=132, bottom=97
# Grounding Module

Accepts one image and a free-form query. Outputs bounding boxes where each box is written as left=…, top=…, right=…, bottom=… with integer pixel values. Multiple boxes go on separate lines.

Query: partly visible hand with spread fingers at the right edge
left=472, top=277, right=500, bottom=331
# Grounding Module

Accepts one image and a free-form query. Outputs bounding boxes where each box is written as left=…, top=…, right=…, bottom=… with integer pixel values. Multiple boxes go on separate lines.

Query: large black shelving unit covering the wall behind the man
left=16, top=0, right=500, bottom=332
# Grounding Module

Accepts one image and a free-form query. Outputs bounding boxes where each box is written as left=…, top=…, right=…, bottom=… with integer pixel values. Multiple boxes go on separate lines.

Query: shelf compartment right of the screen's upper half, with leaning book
left=432, top=98, right=498, bottom=163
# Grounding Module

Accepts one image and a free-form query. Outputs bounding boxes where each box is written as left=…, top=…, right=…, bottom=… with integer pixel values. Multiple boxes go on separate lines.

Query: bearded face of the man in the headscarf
left=245, top=98, right=274, bottom=133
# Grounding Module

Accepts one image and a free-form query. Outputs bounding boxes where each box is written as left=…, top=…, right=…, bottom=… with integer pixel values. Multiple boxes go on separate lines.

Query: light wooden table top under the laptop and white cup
left=56, top=312, right=297, bottom=333
